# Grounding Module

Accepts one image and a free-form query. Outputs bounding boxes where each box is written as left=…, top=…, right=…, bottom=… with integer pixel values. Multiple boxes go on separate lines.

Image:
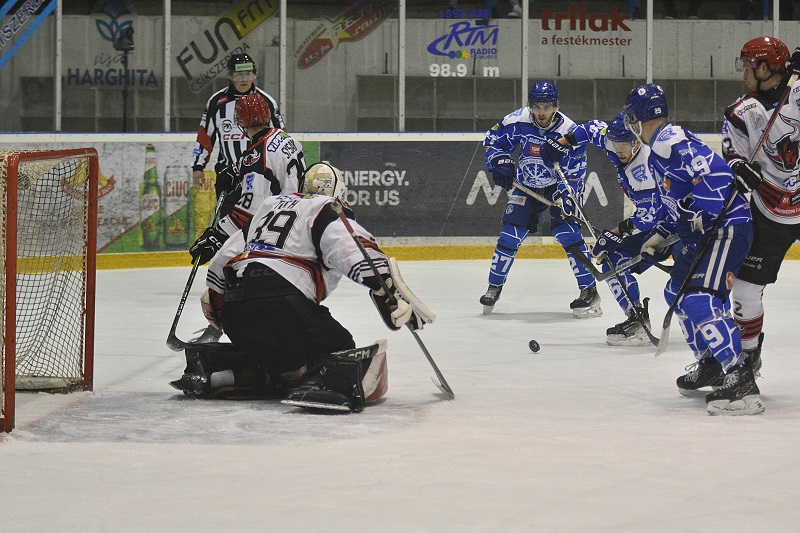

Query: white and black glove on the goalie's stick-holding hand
left=368, top=257, right=436, bottom=331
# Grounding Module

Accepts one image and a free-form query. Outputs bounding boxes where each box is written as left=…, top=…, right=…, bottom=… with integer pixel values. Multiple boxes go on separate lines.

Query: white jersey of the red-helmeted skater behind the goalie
left=218, top=129, right=306, bottom=235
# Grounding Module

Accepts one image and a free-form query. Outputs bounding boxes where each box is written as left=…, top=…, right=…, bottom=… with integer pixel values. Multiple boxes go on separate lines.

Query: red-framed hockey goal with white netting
left=0, top=148, right=98, bottom=431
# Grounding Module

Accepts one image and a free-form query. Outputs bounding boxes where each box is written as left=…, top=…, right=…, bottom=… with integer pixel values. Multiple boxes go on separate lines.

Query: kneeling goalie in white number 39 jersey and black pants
left=171, top=162, right=435, bottom=412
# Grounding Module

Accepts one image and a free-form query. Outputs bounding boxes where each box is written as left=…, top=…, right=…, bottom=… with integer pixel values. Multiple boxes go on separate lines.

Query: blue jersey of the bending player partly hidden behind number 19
left=572, top=120, right=663, bottom=234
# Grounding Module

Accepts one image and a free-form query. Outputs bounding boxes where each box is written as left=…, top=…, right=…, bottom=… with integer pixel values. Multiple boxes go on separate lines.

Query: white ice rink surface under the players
left=0, top=260, right=800, bottom=532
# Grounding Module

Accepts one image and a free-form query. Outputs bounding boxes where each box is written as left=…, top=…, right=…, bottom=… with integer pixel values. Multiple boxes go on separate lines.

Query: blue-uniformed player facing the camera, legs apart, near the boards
left=480, top=81, right=603, bottom=318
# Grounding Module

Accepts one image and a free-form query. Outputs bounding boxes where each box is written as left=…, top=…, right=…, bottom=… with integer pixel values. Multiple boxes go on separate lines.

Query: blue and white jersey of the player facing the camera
left=483, top=107, right=586, bottom=191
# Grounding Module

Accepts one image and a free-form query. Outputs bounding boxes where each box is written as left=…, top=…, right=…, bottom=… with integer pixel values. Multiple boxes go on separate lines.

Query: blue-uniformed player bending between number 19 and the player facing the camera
left=542, top=113, right=669, bottom=346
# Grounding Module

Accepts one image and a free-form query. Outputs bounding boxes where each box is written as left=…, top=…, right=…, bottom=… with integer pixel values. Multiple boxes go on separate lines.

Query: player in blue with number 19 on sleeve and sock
left=624, top=84, right=764, bottom=415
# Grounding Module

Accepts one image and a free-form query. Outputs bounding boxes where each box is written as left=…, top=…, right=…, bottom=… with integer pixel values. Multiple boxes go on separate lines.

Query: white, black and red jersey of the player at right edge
left=722, top=77, right=800, bottom=224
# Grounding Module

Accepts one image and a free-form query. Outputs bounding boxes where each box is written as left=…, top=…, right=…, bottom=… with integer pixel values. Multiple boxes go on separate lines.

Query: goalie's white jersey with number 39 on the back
left=206, top=193, right=389, bottom=303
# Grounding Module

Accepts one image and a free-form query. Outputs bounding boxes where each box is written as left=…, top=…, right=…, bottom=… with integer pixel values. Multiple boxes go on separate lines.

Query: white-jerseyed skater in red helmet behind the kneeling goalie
left=189, top=93, right=305, bottom=265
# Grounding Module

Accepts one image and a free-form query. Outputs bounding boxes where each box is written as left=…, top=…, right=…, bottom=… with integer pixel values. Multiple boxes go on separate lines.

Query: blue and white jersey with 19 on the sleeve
left=649, top=122, right=753, bottom=234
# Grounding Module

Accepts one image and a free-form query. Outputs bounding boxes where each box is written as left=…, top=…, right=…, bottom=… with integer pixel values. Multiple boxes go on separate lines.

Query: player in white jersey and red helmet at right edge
left=722, top=37, right=800, bottom=375
